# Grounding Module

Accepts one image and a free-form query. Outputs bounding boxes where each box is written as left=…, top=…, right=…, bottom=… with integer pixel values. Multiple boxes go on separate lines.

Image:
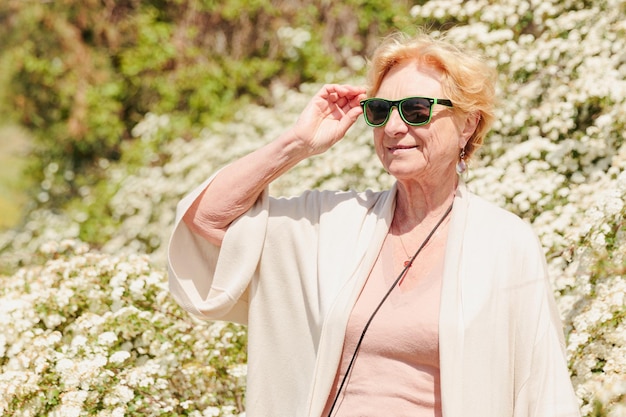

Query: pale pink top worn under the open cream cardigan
left=322, top=234, right=443, bottom=417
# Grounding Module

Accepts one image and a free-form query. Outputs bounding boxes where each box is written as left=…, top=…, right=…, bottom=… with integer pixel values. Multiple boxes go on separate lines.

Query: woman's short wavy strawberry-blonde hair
left=367, top=32, right=497, bottom=158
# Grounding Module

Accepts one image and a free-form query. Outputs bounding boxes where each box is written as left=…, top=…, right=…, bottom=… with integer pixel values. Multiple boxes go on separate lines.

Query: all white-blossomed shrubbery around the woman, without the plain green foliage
left=0, top=0, right=626, bottom=417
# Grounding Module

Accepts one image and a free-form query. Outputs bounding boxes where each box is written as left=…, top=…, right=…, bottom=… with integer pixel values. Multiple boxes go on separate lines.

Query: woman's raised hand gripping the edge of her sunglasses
left=292, top=84, right=366, bottom=155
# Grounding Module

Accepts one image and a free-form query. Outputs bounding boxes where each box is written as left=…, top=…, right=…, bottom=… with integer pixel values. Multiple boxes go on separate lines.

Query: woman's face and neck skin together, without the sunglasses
left=374, top=62, right=476, bottom=229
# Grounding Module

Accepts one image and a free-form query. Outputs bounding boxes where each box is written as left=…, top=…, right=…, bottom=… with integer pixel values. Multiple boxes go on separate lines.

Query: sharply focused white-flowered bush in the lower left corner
left=0, top=241, right=246, bottom=417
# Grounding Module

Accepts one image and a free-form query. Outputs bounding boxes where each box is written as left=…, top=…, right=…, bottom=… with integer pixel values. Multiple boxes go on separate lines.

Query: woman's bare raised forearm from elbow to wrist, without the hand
left=184, top=130, right=310, bottom=246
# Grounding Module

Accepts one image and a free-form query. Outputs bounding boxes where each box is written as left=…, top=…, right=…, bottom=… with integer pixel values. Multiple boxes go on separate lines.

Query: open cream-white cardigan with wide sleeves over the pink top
left=169, top=178, right=579, bottom=417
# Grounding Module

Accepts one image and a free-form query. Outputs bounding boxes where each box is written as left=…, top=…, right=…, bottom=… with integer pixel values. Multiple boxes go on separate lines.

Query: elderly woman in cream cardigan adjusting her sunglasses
left=169, top=30, right=578, bottom=417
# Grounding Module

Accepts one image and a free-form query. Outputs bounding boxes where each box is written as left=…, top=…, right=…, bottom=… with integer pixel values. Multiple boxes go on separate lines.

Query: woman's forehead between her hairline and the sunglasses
left=376, top=61, right=445, bottom=100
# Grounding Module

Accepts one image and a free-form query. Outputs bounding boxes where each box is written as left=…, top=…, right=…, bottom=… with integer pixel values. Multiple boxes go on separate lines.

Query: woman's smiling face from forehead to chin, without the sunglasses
left=374, top=62, right=468, bottom=182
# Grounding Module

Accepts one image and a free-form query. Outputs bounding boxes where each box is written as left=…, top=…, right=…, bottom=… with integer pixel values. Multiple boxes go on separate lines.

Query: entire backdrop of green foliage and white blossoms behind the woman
left=0, top=0, right=626, bottom=416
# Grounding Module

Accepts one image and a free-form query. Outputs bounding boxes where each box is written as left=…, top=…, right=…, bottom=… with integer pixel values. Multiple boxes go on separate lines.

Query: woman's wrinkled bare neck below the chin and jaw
left=394, top=175, right=458, bottom=232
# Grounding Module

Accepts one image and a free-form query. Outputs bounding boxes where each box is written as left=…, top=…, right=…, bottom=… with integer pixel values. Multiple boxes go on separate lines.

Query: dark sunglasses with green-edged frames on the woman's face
left=361, top=97, right=452, bottom=127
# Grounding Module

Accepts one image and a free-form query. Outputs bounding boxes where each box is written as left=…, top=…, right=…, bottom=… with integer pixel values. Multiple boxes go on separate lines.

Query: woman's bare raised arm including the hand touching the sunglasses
left=183, top=84, right=365, bottom=246
